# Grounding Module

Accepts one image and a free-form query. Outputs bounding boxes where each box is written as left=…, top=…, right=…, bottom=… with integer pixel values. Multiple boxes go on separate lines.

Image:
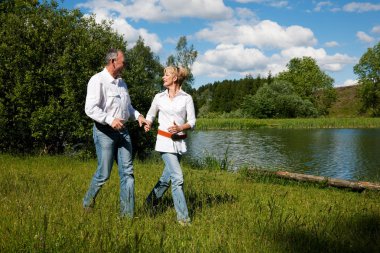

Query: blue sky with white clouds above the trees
left=61, top=0, right=380, bottom=88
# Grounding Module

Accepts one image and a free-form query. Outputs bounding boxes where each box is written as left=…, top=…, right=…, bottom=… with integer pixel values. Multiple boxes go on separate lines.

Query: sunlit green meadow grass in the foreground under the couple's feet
left=0, top=155, right=380, bottom=252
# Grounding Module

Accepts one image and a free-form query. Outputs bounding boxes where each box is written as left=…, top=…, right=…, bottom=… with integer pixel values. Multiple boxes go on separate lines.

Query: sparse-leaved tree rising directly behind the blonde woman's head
left=166, top=36, right=198, bottom=92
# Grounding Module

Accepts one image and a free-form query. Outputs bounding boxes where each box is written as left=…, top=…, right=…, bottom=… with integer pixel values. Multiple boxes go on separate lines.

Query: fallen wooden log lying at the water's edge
left=274, top=171, right=380, bottom=191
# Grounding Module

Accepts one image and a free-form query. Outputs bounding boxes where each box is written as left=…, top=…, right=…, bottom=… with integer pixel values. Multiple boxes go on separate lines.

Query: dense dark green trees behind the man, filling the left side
left=0, top=0, right=161, bottom=156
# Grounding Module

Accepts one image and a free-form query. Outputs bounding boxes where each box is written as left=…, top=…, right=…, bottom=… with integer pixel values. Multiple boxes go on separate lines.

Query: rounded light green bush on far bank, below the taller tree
left=242, top=80, right=317, bottom=118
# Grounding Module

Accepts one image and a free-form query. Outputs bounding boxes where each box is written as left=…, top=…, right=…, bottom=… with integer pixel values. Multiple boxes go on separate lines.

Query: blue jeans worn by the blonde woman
left=149, top=153, right=189, bottom=221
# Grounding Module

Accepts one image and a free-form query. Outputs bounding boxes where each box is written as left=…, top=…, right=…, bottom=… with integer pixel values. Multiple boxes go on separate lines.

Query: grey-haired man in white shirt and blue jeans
left=83, top=49, right=146, bottom=218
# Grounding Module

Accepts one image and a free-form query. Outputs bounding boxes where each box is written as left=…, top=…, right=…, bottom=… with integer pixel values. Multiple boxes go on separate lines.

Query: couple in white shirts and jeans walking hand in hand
left=83, top=49, right=196, bottom=225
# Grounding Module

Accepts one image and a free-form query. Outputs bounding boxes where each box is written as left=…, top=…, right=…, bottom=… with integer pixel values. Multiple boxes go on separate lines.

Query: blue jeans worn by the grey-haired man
left=83, top=125, right=135, bottom=218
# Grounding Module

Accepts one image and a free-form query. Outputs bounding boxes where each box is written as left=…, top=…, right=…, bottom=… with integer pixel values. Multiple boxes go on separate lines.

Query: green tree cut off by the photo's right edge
left=354, top=42, right=380, bottom=116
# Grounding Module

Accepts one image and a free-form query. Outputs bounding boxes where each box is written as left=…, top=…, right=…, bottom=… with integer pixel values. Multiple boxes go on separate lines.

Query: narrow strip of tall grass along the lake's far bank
left=197, top=118, right=380, bottom=130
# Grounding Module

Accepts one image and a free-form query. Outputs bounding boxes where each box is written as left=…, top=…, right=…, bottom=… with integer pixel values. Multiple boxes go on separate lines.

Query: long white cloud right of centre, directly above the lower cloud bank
left=196, top=20, right=317, bottom=48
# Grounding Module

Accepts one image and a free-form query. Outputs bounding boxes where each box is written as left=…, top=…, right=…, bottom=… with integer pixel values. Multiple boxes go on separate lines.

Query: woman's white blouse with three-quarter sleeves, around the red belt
left=146, top=90, right=196, bottom=154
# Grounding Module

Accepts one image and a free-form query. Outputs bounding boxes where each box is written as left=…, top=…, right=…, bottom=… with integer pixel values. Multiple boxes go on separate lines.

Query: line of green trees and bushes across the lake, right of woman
left=194, top=57, right=336, bottom=118
